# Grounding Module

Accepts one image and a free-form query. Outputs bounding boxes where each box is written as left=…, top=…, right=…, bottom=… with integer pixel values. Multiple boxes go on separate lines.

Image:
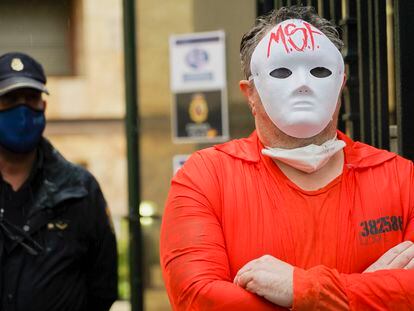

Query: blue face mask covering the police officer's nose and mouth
left=0, top=105, right=46, bottom=153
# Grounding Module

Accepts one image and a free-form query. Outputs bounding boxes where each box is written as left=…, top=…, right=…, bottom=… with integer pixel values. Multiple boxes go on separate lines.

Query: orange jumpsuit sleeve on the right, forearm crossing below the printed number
left=293, top=168, right=414, bottom=311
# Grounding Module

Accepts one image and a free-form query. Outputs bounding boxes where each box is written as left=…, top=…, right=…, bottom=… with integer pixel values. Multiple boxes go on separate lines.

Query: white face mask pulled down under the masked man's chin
left=262, top=137, right=346, bottom=173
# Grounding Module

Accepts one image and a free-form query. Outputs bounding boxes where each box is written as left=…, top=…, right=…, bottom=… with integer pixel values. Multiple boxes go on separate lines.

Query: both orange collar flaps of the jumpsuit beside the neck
left=214, top=131, right=397, bottom=168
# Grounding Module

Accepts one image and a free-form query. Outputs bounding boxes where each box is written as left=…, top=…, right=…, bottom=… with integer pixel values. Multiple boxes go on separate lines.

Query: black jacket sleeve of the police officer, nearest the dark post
left=86, top=179, right=118, bottom=311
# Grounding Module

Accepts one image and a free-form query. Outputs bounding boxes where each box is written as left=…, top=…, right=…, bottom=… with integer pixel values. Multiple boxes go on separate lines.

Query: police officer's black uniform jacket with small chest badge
left=0, top=139, right=117, bottom=311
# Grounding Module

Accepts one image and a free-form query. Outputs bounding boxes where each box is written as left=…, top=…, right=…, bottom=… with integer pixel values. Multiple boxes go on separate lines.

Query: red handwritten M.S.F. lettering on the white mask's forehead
left=267, top=22, right=322, bottom=57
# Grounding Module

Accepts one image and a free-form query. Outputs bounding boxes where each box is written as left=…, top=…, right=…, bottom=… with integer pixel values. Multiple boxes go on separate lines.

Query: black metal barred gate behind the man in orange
left=257, top=0, right=414, bottom=159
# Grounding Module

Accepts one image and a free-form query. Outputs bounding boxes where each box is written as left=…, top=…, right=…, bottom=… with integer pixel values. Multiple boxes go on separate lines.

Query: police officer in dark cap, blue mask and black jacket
left=0, top=53, right=117, bottom=311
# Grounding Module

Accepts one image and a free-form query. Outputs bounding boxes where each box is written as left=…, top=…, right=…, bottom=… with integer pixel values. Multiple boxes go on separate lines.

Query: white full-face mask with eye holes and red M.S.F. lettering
left=249, top=19, right=344, bottom=138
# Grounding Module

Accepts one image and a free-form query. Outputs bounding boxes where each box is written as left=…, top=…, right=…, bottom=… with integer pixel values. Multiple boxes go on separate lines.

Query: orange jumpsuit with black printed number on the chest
left=160, top=132, right=414, bottom=311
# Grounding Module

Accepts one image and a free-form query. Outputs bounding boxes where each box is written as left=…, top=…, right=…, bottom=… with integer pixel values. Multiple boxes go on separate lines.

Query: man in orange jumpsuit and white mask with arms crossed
left=161, top=7, right=414, bottom=310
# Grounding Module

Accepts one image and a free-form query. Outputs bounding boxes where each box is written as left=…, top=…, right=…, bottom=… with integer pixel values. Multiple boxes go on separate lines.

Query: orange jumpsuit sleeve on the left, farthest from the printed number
left=160, top=154, right=284, bottom=311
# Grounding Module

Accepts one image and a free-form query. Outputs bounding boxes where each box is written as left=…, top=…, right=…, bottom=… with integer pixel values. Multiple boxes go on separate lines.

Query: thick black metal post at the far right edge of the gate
left=394, top=0, right=414, bottom=160
